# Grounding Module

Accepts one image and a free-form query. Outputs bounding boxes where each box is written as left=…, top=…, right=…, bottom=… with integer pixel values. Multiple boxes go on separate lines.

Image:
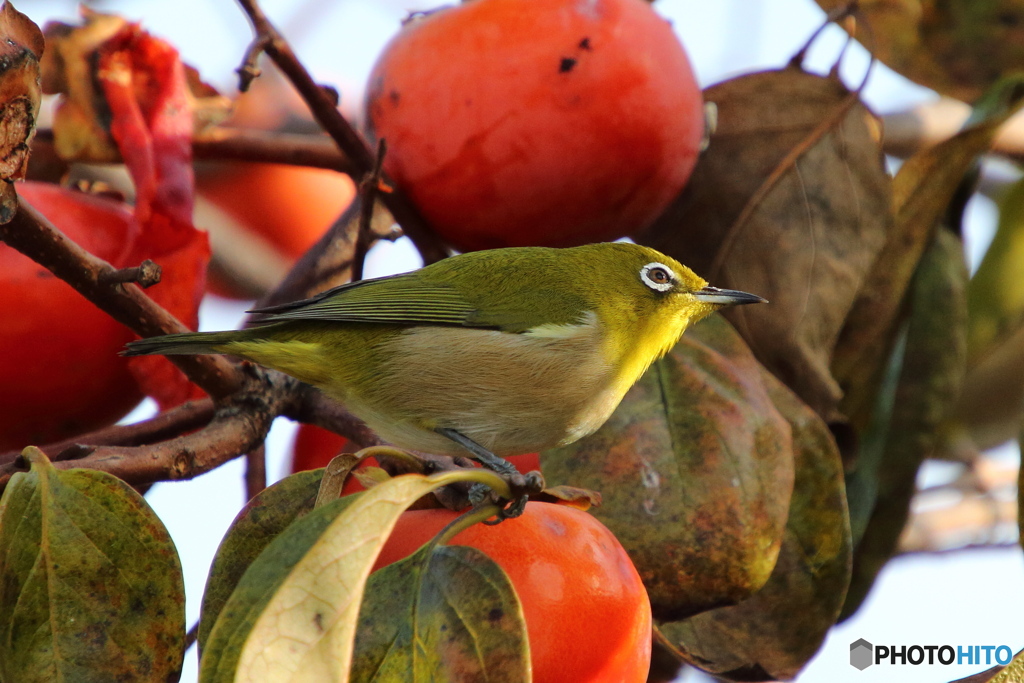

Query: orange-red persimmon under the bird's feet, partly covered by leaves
left=374, top=503, right=651, bottom=683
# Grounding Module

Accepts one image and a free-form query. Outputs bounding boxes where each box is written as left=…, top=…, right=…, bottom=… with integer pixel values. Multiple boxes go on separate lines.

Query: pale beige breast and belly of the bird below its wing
left=356, top=314, right=622, bottom=455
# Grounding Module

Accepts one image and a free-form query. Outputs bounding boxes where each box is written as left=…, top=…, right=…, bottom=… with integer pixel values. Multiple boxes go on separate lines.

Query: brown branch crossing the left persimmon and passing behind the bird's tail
left=0, top=198, right=241, bottom=397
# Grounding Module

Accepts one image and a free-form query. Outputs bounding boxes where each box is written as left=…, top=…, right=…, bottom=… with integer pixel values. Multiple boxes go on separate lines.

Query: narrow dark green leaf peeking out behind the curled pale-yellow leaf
left=199, top=469, right=324, bottom=652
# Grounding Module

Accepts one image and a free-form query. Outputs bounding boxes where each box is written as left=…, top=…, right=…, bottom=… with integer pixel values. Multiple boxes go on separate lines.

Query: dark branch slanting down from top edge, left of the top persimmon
left=239, top=0, right=447, bottom=263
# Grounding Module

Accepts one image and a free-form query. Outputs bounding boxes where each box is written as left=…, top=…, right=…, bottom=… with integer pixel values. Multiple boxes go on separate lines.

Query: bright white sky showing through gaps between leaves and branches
left=15, top=0, right=1024, bottom=683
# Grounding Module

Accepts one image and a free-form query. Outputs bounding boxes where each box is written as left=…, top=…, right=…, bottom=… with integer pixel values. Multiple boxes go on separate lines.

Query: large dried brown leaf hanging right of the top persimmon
left=639, top=67, right=892, bottom=421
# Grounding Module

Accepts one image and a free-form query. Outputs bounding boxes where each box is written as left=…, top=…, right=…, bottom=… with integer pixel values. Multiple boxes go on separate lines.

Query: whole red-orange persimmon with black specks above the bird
left=367, top=0, right=703, bottom=251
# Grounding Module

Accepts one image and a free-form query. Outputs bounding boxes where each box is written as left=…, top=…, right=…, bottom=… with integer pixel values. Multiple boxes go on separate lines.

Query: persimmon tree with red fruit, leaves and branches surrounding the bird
left=0, top=0, right=1024, bottom=683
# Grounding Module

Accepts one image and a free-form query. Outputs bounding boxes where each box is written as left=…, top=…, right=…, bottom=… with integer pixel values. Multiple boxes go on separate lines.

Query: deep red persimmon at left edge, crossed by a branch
left=0, top=182, right=143, bottom=451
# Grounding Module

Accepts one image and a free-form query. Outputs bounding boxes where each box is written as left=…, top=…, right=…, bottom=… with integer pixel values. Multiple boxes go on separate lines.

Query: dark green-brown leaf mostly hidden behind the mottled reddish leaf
left=658, top=381, right=851, bottom=681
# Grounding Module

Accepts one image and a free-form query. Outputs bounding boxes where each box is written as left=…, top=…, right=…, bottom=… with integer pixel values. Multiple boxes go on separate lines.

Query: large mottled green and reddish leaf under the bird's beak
left=541, top=315, right=794, bottom=618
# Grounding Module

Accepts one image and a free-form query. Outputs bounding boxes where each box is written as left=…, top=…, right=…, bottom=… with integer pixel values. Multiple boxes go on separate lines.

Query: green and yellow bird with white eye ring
left=126, top=243, right=764, bottom=473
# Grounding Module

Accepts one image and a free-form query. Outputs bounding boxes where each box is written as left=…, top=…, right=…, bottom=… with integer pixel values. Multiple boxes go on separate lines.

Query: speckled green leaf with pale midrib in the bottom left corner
left=0, top=447, right=184, bottom=683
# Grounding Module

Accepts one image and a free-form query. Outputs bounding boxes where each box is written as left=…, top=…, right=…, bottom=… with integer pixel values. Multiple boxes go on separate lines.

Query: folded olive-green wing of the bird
left=250, top=273, right=487, bottom=328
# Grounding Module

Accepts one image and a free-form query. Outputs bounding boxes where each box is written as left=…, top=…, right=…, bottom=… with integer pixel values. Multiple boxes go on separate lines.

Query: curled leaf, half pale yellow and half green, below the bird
left=200, top=470, right=503, bottom=683
